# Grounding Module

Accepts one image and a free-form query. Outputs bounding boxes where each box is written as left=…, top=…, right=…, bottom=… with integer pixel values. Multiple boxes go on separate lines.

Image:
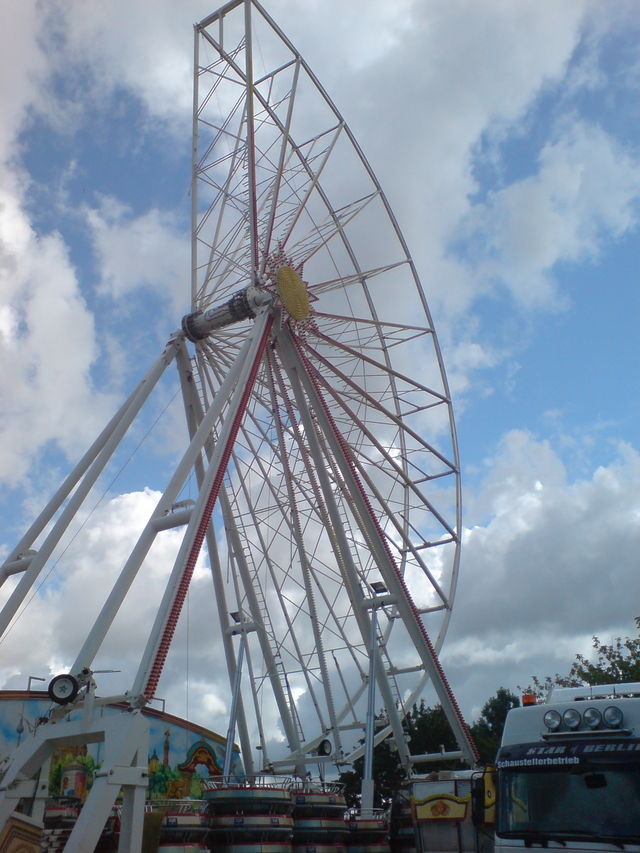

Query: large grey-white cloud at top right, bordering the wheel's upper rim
left=336, top=2, right=587, bottom=313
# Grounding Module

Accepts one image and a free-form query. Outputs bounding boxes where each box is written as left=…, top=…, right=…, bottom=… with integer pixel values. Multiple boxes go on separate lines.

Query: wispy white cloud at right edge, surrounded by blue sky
left=464, top=119, right=640, bottom=307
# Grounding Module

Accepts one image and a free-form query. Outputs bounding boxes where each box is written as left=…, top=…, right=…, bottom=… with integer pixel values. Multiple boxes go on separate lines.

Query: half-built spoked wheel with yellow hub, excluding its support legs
left=183, top=3, right=476, bottom=769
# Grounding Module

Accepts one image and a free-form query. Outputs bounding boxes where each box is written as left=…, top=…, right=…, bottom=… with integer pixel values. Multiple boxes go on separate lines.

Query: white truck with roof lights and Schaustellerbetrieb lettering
left=473, top=682, right=640, bottom=853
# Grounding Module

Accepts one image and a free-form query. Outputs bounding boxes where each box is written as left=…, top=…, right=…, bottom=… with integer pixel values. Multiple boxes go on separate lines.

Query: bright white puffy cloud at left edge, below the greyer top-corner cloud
left=0, top=180, right=114, bottom=485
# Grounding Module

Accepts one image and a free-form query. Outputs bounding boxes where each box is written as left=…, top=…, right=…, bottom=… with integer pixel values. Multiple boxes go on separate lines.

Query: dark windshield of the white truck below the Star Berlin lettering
left=496, top=761, right=640, bottom=842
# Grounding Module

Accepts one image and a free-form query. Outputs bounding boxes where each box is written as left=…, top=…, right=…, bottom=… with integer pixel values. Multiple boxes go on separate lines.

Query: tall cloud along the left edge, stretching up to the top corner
left=0, top=2, right=122, bottom=492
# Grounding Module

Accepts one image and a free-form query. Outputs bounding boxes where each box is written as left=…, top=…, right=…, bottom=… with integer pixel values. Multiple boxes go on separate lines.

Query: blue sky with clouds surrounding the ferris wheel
left=0, top=0, right=640, bottom=760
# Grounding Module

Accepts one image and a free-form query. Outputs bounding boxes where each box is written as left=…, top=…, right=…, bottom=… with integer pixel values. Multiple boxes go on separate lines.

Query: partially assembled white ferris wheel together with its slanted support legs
left=0, top=0, right=474, bottom=849
